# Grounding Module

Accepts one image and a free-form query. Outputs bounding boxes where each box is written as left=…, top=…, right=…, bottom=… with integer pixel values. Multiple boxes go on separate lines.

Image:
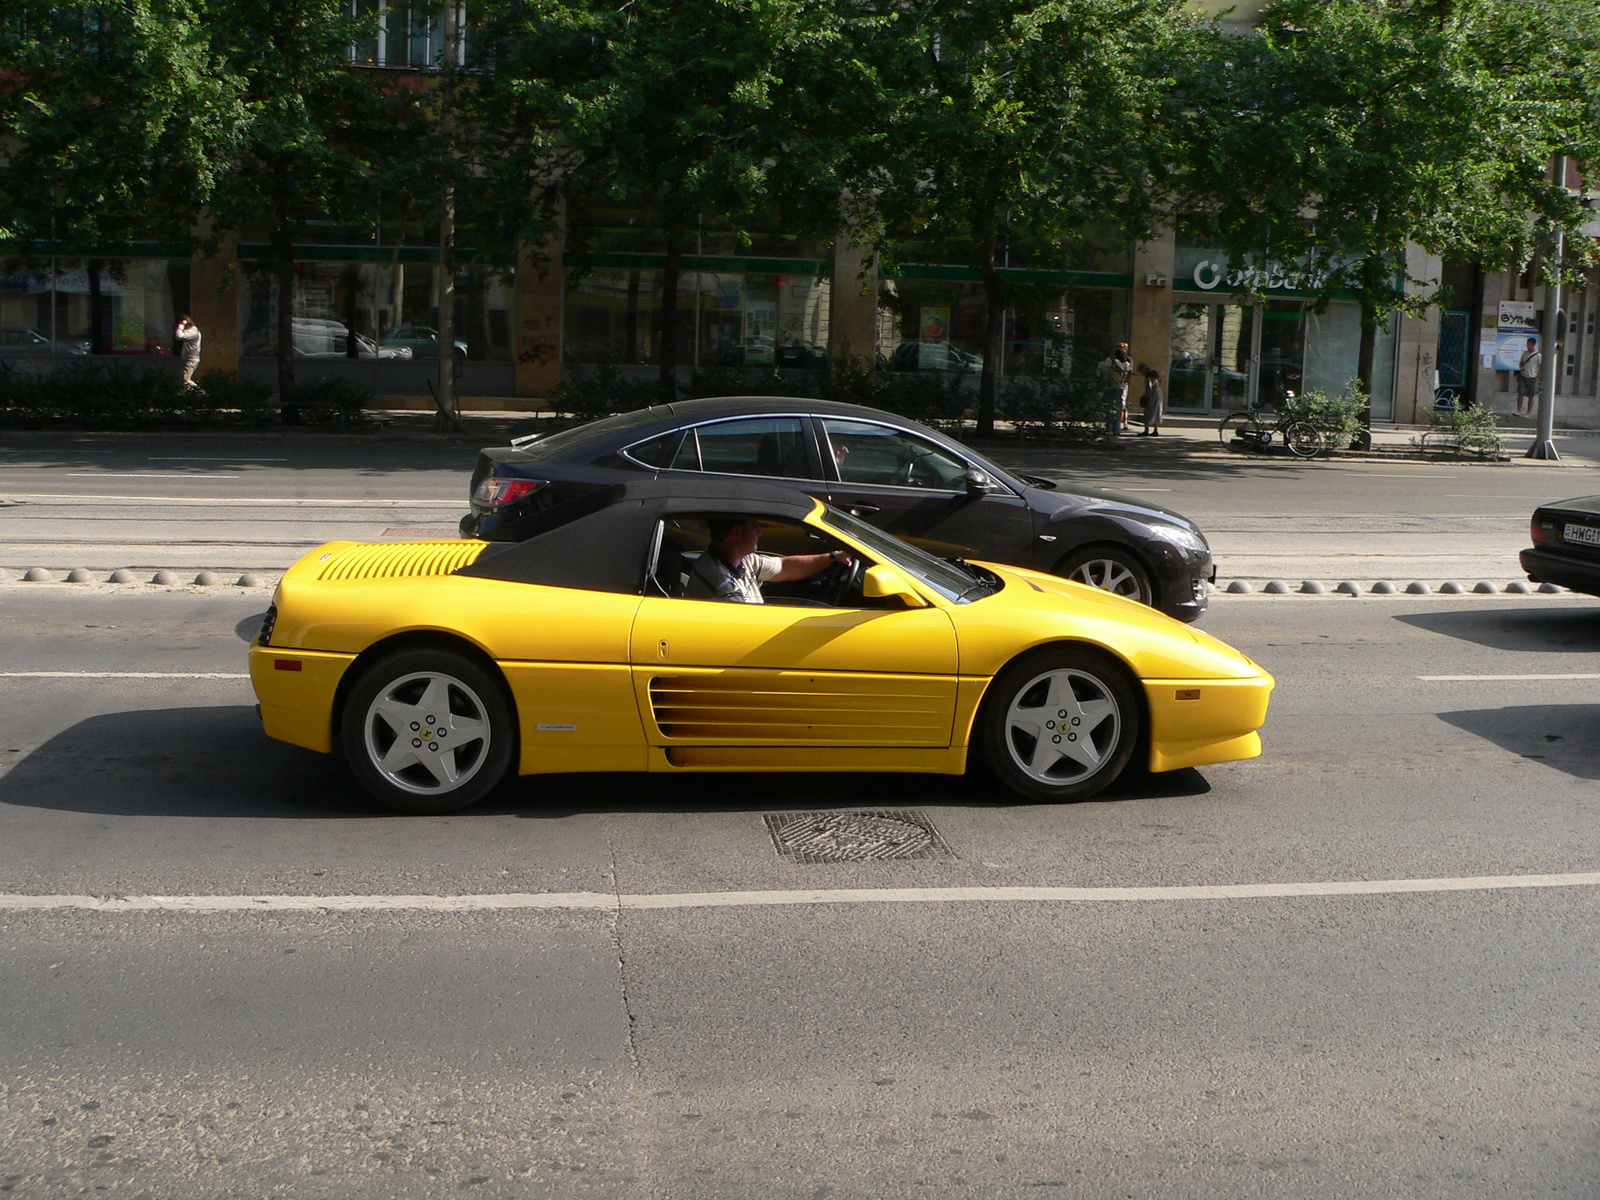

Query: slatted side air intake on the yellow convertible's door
left=650, top=672, right=950, bottom=746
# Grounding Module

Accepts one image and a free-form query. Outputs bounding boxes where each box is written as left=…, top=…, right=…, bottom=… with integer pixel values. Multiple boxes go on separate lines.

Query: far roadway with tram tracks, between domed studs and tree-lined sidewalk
left=0, top=430, right=1600, bottom=586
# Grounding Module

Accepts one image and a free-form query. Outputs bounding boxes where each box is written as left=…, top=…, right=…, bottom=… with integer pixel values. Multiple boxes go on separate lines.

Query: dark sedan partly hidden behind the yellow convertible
left=461, top=397, right=1214, bottom=621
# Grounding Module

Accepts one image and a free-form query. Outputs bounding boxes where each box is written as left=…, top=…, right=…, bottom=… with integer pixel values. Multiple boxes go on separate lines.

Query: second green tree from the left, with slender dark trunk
left=205, top=0, right=412, bottom=404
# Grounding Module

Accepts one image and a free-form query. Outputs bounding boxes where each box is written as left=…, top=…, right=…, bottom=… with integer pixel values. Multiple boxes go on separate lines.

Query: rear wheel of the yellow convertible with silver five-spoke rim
left=339, top=648, right=517, bottom=814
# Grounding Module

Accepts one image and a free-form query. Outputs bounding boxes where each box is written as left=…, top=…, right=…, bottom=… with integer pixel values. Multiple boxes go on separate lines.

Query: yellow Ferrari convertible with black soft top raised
left=250, top=482, right=1272, bottom=813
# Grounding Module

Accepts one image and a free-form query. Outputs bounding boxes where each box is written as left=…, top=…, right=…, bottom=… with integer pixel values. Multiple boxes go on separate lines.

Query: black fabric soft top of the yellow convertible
left=456, top=478, right=816, bottom=594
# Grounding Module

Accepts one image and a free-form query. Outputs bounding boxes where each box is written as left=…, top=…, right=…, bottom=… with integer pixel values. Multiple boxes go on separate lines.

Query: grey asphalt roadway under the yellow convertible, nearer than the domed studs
left=0, top=586, right=1600, bottom=1200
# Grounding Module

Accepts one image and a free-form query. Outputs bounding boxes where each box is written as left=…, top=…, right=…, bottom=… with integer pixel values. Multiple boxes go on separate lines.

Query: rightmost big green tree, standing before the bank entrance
left=1189, top=0, right=1597, bottom=406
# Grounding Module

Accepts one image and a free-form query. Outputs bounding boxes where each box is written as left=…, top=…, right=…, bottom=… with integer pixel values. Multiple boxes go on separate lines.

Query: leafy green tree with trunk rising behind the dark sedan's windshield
left=850, top=0, right=1198, bottom=434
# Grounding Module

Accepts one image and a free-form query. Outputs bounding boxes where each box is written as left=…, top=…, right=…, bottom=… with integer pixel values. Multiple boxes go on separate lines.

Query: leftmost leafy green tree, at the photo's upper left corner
left=0, top=0, right=242, bottom=354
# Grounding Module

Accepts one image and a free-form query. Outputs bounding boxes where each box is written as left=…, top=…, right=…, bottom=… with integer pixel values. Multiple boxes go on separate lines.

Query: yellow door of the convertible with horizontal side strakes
left=630, top=597, right=957, bottom=755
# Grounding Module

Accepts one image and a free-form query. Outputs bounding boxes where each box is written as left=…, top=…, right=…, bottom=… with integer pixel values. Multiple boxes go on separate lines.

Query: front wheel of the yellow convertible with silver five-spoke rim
left=978, top=645, right=1144, bottom=802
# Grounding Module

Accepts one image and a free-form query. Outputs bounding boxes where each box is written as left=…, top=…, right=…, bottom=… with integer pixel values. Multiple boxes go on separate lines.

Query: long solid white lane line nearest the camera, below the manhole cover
left=9, top=870, right=1600, bottom=912
